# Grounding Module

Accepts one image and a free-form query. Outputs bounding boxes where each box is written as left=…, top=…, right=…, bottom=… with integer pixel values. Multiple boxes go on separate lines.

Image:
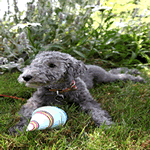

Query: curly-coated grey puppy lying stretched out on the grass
left=9, top=51, right=144, bottom=133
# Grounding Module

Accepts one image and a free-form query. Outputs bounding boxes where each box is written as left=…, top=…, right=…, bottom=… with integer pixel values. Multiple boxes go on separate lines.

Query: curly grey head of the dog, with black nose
left=18, top=51, right=86, bottom=88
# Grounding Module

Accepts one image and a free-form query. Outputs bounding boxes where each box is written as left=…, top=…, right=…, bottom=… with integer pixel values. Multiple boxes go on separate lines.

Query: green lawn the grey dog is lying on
left=0, top=70, right=150, bottom=150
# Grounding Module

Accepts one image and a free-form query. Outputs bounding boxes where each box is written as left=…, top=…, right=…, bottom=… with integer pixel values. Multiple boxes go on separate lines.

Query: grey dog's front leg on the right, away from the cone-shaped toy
left=75, top=80, right=114, bottom=126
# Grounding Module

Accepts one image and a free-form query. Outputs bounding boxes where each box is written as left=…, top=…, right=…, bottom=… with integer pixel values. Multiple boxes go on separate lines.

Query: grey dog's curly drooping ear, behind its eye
left=67, top=57, right=87, bottom=78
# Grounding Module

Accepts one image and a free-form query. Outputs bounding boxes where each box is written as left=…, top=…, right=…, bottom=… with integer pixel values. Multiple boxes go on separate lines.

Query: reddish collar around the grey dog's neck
left=49, top=80, right=77, bottom=93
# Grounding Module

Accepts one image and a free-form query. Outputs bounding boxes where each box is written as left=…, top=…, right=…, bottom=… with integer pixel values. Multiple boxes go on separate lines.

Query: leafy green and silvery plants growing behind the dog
left=0, top=0, right=150, bottom=66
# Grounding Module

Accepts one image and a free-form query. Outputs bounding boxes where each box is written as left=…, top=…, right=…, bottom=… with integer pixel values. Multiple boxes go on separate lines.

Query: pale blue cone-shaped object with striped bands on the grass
left=26, top=106, right=67, bottom=131
